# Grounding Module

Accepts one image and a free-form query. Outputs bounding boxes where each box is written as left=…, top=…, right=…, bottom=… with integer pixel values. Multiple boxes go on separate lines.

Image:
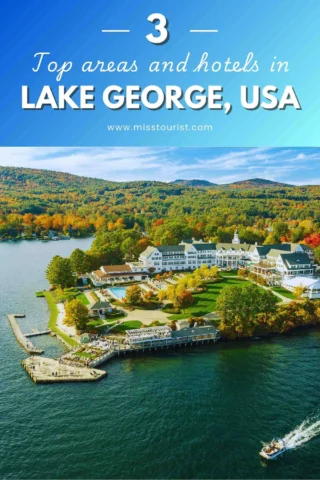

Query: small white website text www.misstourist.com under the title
left=107, top=123, right=213, bottom=132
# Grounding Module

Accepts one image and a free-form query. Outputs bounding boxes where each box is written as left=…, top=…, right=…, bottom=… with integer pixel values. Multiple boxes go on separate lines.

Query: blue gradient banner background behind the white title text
left=0, top=0, right=320, bottom=147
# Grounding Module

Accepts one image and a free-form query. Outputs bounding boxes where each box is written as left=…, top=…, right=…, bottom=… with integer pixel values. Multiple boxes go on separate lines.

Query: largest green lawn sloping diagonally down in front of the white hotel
left=169, top=277, right=250, bottom=320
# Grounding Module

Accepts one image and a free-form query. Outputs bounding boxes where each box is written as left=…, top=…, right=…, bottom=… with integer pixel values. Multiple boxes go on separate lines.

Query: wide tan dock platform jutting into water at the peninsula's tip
left=21, top=356, right=107, bottom=383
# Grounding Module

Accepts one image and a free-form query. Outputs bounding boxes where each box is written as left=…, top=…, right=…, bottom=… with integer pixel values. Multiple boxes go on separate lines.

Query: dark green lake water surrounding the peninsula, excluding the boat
left=0, top=240, right=320, bottom=479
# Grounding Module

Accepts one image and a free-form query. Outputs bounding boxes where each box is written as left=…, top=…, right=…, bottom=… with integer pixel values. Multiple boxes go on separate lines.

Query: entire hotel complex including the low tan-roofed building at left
left=90, top=232, right=320, bottom=292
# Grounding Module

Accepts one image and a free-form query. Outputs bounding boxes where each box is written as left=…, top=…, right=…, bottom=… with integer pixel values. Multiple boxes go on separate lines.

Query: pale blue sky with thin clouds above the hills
left=0, top=147, right=320, bottom=185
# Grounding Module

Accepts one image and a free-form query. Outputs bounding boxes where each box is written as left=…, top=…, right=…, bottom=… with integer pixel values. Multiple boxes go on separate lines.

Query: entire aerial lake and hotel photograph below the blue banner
left=0, top=147, right=320, bottom=479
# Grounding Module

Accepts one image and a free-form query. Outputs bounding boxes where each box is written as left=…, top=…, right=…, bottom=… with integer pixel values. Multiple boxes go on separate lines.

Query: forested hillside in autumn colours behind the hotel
left=0, top=167, right=320, bottom=256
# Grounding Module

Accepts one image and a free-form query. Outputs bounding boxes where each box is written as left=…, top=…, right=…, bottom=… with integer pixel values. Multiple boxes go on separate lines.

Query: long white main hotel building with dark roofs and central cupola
left=136, top=232, right=315, bottom=278
